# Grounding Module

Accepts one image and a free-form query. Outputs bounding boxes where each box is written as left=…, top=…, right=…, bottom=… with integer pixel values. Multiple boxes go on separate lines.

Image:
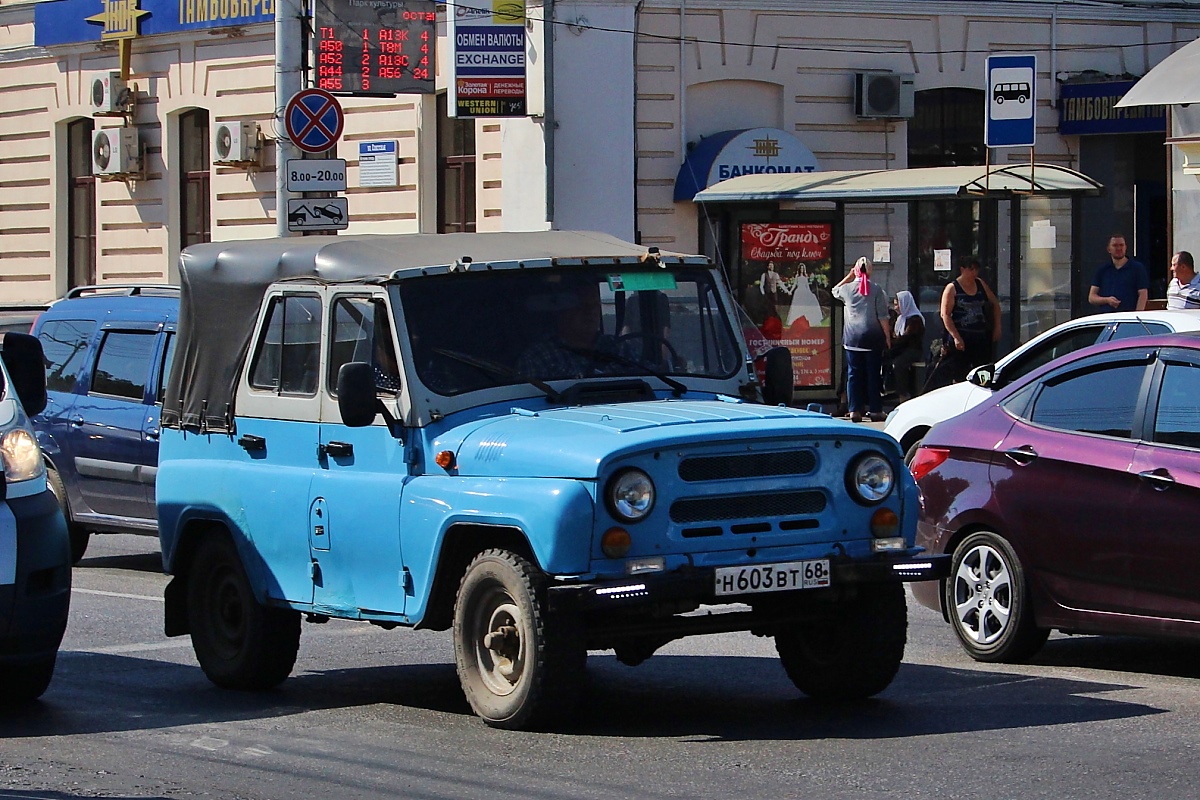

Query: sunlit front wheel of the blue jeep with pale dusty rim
left=454, top=549, right=587, bottom=729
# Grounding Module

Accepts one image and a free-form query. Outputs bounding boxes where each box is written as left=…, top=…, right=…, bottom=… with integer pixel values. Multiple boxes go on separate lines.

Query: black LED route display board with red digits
left=313, top=0, right=438, bottom=95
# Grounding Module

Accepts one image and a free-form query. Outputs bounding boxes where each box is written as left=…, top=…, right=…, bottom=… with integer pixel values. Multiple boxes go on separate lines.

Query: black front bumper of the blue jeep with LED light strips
left=548, top=555, right=950, bottom=612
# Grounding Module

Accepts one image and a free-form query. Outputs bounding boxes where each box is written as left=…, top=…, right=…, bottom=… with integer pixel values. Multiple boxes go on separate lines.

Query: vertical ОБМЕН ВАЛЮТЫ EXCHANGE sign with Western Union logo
left=448, top=0, right=526, bottom=118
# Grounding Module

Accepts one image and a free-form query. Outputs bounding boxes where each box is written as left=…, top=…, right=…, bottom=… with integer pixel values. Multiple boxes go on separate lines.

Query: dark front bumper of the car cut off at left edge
left=0, top=491, right=71, bottom=663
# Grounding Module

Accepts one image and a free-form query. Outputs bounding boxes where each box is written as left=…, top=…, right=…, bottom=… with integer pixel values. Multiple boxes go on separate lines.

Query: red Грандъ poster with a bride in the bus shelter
left=740, top=222, right=833, bottom=386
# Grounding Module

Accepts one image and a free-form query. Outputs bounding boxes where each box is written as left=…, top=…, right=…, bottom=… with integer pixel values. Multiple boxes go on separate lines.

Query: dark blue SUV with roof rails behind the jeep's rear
left=32, top=285, right=179, bottom=561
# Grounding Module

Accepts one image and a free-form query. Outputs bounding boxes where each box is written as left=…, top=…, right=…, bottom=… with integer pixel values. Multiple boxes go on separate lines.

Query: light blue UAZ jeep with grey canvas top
left=157, top=231, right=946, bottom=728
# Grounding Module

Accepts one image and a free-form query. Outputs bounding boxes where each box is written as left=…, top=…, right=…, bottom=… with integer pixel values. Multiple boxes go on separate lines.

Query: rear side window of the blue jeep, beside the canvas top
left=250, top=295, right=320, bottom=395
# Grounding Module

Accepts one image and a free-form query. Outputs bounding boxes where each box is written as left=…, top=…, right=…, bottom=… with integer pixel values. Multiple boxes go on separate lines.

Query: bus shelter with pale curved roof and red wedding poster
left=694, top=163, right=1103, bottom=399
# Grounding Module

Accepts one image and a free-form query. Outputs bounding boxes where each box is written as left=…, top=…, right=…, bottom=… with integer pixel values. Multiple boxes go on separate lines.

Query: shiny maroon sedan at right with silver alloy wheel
left=911, top=333, right=1200, bottom=662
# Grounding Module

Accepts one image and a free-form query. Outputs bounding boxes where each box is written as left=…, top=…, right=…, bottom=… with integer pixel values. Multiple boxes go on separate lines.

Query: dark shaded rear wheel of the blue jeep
left=187, top=535, right=300, bottom=690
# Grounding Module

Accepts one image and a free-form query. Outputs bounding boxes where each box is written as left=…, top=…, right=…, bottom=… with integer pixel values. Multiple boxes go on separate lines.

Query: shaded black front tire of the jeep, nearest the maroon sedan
left=775, top=583, right=908, bottom=700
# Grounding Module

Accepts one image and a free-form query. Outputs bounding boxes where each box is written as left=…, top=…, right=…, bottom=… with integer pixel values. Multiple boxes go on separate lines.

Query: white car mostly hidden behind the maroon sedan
left=883, top=309, right=1200, bottom=461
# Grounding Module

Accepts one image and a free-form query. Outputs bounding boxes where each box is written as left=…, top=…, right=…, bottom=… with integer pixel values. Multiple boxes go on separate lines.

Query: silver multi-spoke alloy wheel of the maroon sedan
left=943, top=530, right=1050, bottom=663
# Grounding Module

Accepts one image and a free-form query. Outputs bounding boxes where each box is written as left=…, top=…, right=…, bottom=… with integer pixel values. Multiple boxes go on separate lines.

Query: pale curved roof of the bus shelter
left=696, top=163, right=1102, bottom=203
